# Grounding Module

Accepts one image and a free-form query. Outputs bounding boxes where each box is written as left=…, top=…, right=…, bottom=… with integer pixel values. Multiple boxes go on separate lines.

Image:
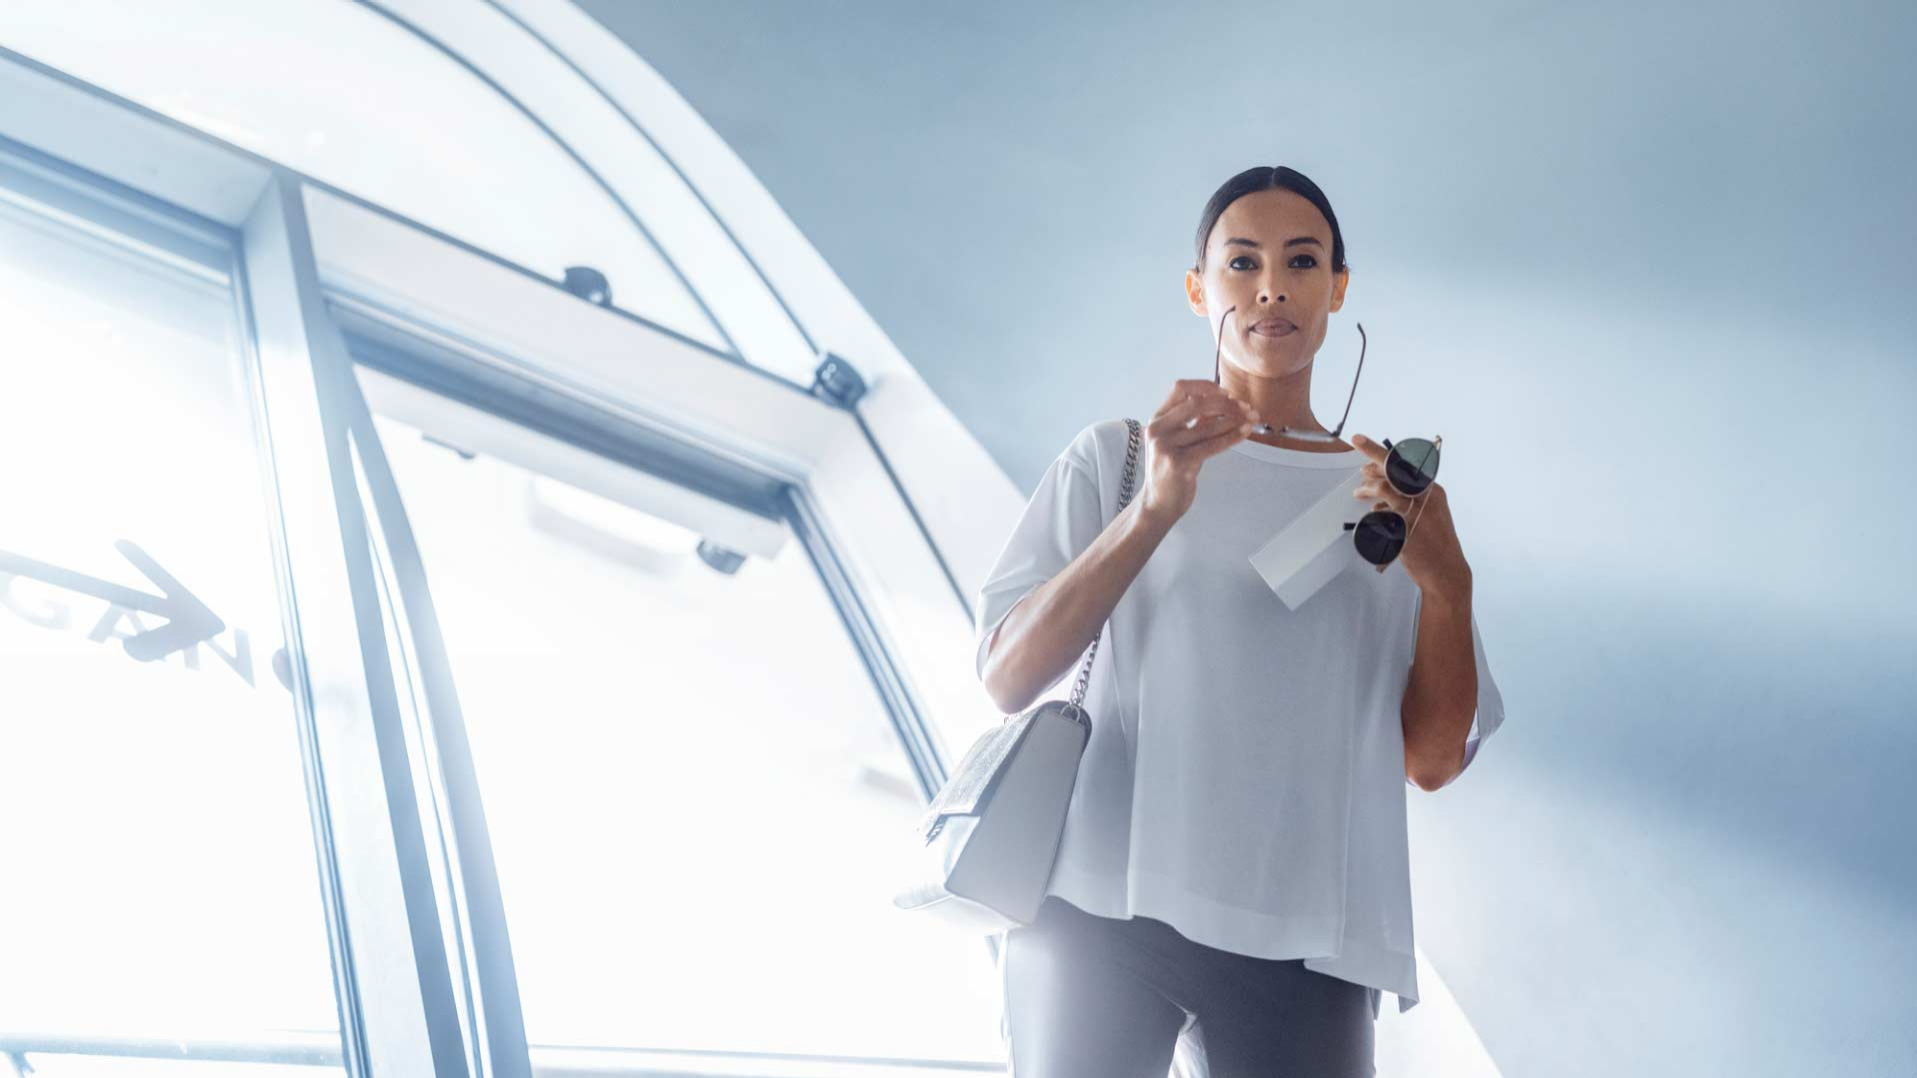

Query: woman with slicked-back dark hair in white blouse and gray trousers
left=976, top=167, right=1503, bottom=1078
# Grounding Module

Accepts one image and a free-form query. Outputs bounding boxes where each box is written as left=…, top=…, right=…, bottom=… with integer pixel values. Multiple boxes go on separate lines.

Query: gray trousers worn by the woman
left=999, top=896, right=1378, bottom=1078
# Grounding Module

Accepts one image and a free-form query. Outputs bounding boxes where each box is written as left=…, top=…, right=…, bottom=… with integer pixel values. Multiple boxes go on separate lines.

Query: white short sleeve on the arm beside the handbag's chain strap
left=974, top=424, right=1104, bottom=681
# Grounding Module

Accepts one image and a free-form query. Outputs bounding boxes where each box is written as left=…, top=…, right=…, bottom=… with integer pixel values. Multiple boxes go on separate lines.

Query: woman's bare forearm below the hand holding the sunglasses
left=1401, top=572, right=1478, bottom=790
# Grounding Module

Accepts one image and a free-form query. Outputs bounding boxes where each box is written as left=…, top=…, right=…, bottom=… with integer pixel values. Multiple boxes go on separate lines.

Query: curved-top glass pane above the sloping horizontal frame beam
left=0, top=0, right=725, bottom=347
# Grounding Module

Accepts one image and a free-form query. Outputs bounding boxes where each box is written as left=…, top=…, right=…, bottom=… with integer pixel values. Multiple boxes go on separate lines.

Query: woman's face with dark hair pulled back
left=1185, top=188, right=1351, bottom=378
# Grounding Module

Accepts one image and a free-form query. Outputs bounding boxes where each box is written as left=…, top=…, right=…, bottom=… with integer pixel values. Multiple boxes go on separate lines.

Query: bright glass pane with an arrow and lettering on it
left=0, top=182, right=339, bottom=1074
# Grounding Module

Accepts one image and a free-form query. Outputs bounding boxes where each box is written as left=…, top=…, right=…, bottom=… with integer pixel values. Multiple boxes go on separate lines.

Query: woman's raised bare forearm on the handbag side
left=983, top=501, right=1175, bottom=714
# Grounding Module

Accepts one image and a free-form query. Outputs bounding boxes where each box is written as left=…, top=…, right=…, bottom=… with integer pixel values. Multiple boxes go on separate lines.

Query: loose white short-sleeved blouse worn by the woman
left=976, top=420, right=1505, bottom=1017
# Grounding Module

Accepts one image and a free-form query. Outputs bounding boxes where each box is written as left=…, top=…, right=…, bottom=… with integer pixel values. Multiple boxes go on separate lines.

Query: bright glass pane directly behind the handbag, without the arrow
left=364, top=400, right=1003, bottom=1063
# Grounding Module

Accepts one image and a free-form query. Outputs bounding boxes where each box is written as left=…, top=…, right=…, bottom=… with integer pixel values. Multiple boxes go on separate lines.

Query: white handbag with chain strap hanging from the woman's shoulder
left=891, top=412, right=1141, bottom=934
